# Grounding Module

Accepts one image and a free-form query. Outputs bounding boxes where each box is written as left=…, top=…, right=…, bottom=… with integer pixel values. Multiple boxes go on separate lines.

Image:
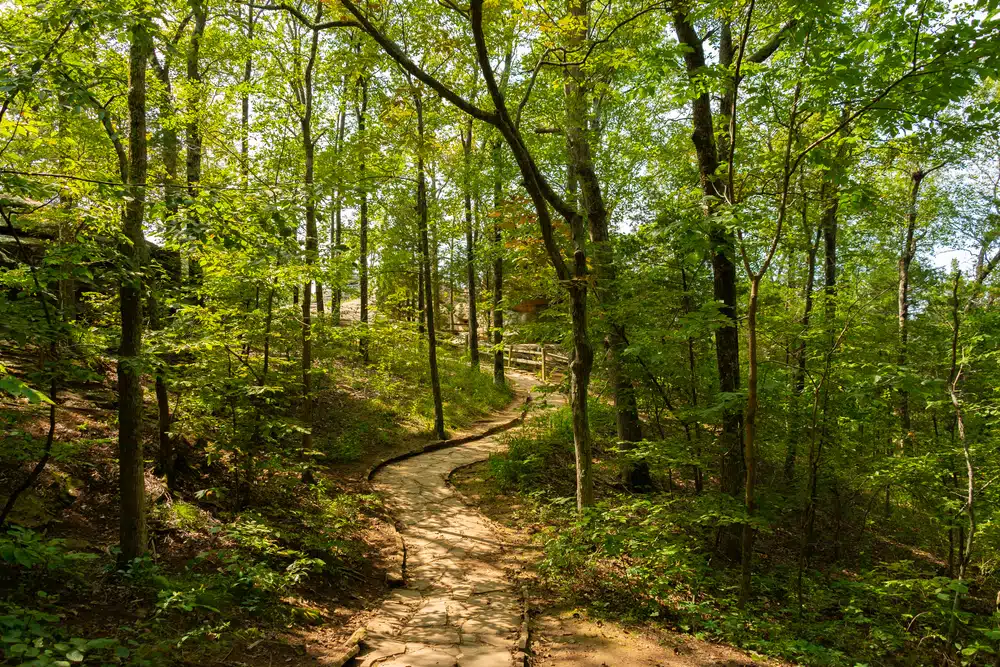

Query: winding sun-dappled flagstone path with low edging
left=357, top=374, right=556, bottom=667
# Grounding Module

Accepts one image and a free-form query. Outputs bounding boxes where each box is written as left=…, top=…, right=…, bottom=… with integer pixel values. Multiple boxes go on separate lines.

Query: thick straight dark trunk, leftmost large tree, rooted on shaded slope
left=118, top=17, right=149, bottom=563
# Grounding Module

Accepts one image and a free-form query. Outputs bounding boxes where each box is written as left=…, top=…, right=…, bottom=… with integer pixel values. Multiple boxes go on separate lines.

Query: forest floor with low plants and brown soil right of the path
left=451, top=402, right=1000, bottom=665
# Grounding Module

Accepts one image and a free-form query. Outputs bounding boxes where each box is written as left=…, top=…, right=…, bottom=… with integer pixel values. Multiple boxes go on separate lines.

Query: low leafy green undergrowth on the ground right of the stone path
left=478, top=404, right=1000, bottom=667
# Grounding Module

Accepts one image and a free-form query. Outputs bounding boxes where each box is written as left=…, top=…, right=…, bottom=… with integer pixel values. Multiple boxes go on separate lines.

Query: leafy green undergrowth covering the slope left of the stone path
left=0, top=320, right=512, bottom=665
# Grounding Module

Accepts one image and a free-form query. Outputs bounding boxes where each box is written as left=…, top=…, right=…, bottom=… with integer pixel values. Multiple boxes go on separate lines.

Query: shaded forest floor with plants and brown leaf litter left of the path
left=0, top=332, right=512, bottom=665
